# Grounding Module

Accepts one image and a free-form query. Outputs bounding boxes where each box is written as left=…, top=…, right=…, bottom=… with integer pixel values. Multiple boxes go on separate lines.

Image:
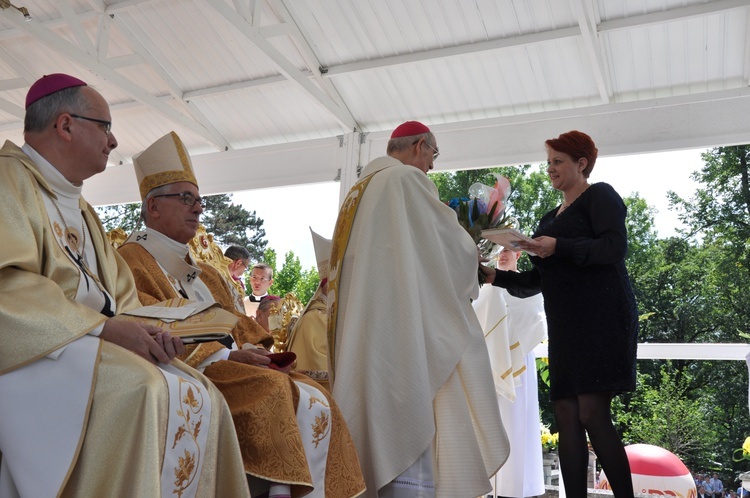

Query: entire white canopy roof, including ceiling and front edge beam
left=0, top=0, right=750, bottom=204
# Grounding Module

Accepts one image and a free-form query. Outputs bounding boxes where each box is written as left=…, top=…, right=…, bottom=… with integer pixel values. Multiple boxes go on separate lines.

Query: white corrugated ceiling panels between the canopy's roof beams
left=0, top=0, right=750, bottom=168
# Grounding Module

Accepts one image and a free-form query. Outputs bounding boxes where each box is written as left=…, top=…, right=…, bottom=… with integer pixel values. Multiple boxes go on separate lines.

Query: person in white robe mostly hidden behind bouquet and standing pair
left=473, top=247, right=547, bottom=498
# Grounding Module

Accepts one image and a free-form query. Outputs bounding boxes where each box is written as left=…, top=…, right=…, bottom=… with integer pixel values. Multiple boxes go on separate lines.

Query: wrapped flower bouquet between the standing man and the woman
left=447, top=174, right=517, bottom=256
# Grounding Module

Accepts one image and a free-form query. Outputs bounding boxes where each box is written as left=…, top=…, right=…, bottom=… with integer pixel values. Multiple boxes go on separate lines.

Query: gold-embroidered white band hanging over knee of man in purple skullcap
left=172, top=378, right=203, bottom=497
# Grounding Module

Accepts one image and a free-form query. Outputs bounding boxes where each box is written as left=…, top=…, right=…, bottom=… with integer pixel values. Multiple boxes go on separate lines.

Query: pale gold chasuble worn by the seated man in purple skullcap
left=0, top=142, right=249, bottom=497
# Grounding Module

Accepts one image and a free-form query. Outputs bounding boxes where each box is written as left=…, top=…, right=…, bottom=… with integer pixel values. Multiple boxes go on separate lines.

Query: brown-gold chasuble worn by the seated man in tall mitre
left=118, top=235, right=364, bottom=498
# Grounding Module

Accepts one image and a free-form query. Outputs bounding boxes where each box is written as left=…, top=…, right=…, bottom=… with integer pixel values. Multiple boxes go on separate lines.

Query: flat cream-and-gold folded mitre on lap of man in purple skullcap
left=115, top=298, right=239, bottom=344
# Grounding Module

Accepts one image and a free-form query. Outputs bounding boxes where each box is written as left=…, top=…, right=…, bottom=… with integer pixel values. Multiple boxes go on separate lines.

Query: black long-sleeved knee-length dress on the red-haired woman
left=493, top=183, right=638, bottom=400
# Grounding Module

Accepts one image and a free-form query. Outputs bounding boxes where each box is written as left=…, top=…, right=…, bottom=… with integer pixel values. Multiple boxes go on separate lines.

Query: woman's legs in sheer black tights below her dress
left=554, top=393, right=633, bottom=498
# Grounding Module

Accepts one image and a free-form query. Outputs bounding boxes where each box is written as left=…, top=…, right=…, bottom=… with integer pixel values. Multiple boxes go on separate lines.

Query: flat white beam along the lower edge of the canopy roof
left=83, top=88, right=750, bottom=205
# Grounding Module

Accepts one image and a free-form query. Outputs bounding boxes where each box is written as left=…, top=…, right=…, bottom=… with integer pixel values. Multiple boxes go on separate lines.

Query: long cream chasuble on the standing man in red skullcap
left=328, top=157, right=509, bottom=498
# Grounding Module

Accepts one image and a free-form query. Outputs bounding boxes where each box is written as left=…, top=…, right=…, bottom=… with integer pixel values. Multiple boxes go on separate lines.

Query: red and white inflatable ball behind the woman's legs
left=599, top=444, right=698, bottom=498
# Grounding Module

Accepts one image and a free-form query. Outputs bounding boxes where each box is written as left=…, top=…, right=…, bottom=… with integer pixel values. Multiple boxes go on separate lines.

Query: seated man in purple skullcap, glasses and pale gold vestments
left=0, top=74, right=250, bottom=498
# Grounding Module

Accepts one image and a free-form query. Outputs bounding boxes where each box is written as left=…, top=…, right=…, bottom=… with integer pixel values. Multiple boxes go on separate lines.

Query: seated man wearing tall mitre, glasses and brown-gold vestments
left=118, top=133, right=364, bottom=498
